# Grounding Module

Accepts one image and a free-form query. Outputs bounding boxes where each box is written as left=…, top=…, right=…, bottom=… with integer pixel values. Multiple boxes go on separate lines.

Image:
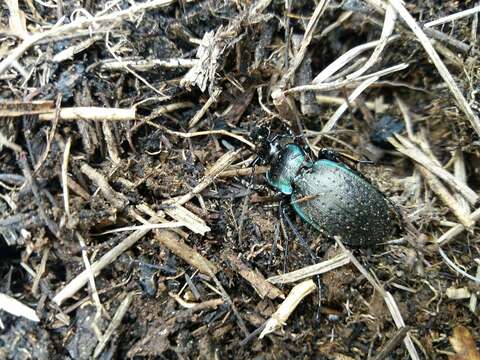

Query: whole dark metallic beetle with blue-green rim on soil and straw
left=259, top=131, right=395, bottom=247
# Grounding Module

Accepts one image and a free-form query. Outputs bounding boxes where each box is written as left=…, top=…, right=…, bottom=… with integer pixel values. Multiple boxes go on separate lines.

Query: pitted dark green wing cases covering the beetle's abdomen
left=292, top=160, right=392, bottom=246
